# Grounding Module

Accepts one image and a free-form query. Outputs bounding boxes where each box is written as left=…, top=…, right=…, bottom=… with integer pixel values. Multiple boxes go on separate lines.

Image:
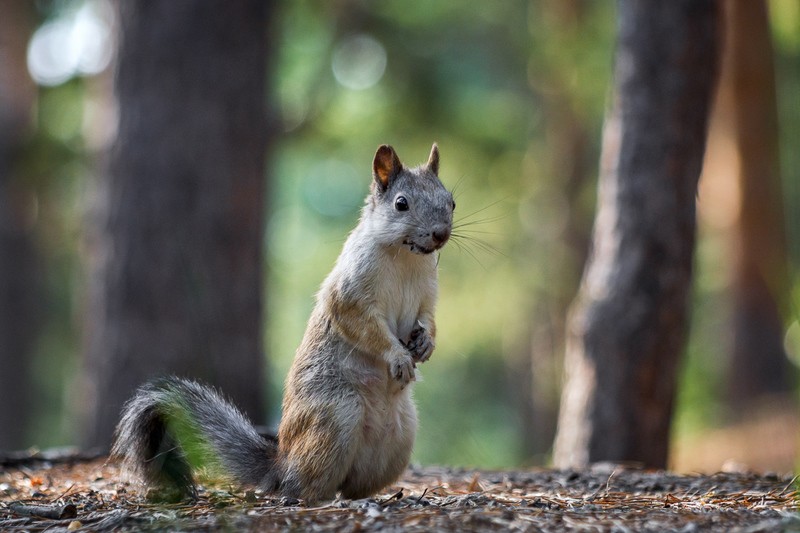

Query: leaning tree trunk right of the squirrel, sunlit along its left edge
left=554, top=0, right=718, bottom=467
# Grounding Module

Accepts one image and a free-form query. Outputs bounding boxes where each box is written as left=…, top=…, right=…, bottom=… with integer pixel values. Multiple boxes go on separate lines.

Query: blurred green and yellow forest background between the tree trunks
left=0, top=0, right=800, bottom=471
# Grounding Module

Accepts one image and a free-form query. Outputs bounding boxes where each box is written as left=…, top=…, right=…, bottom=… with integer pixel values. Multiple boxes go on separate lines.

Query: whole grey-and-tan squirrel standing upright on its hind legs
left=111, top=144, right=455, bottom=502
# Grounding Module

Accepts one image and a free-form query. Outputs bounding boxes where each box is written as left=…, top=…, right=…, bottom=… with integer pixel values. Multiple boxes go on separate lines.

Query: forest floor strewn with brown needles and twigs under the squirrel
left=0, top=454, right=800, bottom=532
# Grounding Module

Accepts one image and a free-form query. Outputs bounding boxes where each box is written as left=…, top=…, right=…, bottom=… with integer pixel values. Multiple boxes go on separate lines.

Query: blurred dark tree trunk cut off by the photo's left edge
left=0, top=0, right=40, bottom=450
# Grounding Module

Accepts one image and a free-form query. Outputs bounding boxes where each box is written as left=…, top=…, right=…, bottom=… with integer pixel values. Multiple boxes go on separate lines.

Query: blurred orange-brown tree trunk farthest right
left=711, top=0, right=794, bottom=413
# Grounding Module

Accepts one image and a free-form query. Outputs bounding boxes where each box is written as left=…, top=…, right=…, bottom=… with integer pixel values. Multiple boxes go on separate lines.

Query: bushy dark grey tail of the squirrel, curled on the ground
left=111, top=377, right=277, bottom=496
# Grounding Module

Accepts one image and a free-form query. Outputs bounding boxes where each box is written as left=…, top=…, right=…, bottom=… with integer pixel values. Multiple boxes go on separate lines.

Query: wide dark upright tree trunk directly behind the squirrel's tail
left=85, top=0, right=274, bottom=445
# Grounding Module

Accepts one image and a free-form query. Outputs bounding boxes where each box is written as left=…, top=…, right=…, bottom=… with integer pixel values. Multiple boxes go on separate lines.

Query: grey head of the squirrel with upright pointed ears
left=366, top=143, right=456, bottom=254
